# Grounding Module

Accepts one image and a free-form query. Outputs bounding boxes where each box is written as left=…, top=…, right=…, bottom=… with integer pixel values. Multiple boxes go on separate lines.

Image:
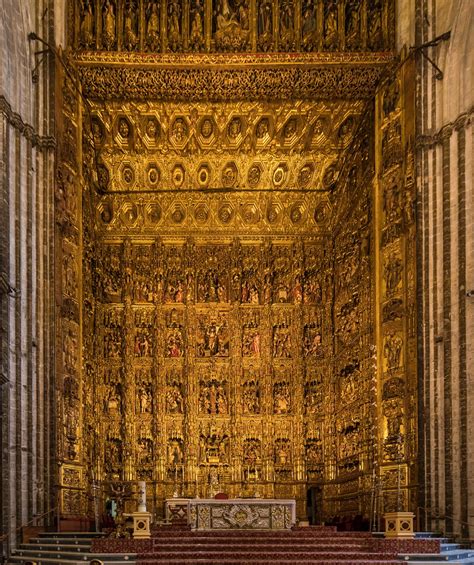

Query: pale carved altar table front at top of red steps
left=188, top=498, right=296, bottom=530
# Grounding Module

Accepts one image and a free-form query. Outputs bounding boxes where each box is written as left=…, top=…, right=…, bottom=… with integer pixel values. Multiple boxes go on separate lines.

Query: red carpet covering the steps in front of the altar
left=93, top=527, right=440, bottom=565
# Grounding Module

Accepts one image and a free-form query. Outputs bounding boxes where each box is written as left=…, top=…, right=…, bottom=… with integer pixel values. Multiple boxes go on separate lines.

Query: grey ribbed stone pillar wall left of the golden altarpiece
left=0, top=0, right=55, bottom=554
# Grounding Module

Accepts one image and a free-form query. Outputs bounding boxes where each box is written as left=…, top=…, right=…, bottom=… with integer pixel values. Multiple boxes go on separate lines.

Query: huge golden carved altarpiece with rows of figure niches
left=55, top=0, right=417, bottom=520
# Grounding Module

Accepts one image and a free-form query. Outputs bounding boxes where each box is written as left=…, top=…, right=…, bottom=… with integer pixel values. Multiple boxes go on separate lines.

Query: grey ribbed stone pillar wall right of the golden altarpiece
left=416, top=0, right=474, bottom=538
